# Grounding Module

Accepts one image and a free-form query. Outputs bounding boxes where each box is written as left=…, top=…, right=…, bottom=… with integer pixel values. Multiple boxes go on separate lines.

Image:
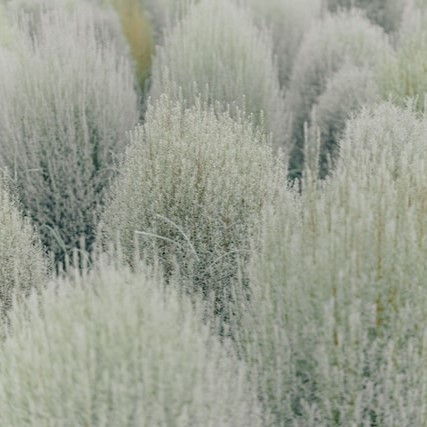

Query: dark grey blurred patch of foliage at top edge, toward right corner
left=326, top=0, right=408, bottom=33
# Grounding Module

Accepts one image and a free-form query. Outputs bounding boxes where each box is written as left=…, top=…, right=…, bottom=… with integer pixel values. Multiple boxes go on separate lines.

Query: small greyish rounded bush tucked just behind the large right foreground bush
left=312, top=65, right=380, bottom=177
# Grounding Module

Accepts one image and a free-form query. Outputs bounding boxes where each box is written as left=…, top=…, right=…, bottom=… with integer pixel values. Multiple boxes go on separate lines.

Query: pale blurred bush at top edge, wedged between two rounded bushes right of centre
left=245, top=0, right=322, bottom=86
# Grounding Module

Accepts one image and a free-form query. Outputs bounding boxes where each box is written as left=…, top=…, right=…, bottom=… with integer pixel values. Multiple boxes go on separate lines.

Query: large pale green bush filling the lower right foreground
left=241, top=104, right=427, bottom=427
